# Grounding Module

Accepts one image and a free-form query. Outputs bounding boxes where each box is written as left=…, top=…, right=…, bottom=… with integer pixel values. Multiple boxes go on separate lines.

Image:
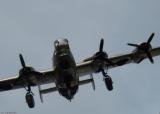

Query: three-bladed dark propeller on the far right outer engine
left=128, top=33, right=155, bottom=64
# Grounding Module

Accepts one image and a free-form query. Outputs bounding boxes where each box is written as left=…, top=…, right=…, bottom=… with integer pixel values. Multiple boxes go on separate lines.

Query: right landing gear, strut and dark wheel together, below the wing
left=102, top=70, right=113, bottom=91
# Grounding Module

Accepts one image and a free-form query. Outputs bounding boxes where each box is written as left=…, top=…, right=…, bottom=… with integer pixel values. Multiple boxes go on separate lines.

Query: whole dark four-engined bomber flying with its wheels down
left=0, top=33, right=160, bottom=108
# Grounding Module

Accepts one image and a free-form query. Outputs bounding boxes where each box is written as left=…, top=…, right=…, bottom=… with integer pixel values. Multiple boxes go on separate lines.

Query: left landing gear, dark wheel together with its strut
left=25, top=86, right=35, bottom=108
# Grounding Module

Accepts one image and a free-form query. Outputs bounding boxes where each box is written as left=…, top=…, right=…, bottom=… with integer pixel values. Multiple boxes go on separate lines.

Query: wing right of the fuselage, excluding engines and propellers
left=77, top=47, right=160, bottom=77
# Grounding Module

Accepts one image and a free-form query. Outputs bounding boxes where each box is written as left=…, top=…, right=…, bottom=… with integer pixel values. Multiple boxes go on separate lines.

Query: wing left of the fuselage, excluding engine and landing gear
left=0, top=70, right=56, bottom=91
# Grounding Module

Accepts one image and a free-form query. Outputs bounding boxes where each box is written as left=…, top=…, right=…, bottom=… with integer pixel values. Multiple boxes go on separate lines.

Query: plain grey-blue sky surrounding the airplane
left=0, top=0, right=160, bottom=114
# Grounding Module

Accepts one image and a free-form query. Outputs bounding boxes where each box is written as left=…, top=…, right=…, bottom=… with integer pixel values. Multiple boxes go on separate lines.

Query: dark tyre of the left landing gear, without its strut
left=26, top=92, right=35, bottom=108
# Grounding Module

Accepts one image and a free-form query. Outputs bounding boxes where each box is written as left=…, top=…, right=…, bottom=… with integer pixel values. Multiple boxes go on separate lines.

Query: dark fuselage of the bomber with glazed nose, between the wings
left=53, top=39, right=79, bottom=100
